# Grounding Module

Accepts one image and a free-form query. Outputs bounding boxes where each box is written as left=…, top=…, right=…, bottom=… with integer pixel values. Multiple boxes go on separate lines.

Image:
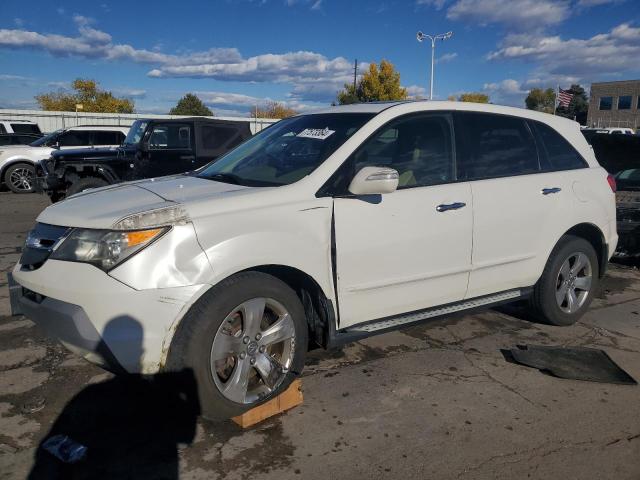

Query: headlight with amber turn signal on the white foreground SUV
left=50, top=227, right=170, bottom=271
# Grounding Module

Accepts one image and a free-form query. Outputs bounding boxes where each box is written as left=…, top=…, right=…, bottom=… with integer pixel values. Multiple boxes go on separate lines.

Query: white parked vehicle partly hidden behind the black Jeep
left=0, top=126, right=129, bottom=193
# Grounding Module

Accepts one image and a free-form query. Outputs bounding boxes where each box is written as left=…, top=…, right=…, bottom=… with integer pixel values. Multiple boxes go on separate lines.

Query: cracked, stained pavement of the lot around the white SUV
left=0, top=193, right=640, bottom=480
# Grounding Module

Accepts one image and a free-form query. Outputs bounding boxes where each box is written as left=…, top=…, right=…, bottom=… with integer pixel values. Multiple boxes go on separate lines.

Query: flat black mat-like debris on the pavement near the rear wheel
left=503, top=345, right=638, bottom=385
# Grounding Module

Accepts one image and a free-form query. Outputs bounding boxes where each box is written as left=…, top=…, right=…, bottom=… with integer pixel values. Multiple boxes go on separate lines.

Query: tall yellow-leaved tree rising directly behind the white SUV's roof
left=338, top=60, right=407, bottom=105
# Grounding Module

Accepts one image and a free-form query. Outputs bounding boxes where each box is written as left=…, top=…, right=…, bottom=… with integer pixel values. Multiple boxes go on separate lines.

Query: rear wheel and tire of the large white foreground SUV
left=530, top=235, right=600, bottom=326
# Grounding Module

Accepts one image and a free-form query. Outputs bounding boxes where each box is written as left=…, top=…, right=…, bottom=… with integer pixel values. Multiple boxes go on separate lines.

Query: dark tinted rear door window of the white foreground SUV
left=455, top=112, right=540, bottom=180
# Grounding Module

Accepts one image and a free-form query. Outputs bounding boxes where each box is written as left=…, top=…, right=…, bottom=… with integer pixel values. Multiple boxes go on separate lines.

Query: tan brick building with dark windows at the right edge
left=587, top=80, right=640, bottom=130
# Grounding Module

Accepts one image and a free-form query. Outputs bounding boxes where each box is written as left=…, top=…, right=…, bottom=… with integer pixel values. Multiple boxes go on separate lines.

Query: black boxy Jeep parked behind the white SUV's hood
left=38, top=117, right=251, bottom=202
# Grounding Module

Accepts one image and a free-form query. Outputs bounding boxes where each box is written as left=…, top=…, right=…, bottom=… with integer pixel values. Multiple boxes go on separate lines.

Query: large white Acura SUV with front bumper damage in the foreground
left=12, top=102, right=618, bottom=417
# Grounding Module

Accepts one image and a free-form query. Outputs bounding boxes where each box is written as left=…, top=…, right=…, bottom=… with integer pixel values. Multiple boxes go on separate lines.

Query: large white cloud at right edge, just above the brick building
left=488, top=23, right=640, bottom=77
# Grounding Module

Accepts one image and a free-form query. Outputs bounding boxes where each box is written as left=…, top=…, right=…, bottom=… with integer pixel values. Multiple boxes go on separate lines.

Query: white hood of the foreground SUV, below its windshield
left=37, top=175, right=253, bottom=229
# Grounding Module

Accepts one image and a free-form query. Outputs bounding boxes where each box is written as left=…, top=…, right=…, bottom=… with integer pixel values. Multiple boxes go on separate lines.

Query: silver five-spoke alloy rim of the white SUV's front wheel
left=210, top=298, right=295, bottom=404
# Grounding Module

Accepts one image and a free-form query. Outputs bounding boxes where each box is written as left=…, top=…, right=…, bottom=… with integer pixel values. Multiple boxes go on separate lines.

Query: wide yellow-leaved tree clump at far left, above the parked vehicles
left=35, top=78, right=135, bottom=113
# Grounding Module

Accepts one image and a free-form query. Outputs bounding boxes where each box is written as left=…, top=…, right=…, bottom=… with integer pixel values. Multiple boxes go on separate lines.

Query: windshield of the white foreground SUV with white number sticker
left=198, top=113, right=373, bottom=186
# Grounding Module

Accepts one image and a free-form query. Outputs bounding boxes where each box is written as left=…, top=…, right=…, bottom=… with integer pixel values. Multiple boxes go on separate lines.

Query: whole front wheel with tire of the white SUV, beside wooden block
left=166, top=272, right=308, bottom=420
